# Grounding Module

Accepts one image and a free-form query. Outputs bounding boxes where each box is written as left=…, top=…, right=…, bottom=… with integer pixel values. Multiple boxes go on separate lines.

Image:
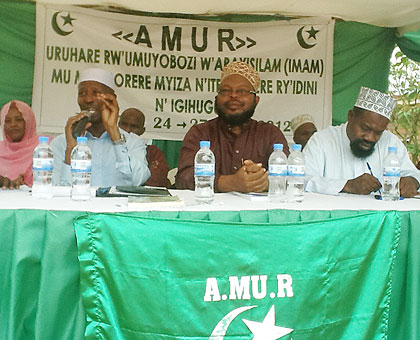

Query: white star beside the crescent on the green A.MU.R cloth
left=242, top=305, right=293, bottom=340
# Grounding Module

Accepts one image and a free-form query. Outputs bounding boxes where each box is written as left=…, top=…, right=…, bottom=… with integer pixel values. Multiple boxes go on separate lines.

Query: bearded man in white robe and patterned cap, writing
left=303, top=87, right=420, bottom=197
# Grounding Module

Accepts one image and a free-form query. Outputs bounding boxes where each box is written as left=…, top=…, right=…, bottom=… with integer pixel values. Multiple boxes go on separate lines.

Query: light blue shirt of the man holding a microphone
left=51, top=129, right=150, bottom=187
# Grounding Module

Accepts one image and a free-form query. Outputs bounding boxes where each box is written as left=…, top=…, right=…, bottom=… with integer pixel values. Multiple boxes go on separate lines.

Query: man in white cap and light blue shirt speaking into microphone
left=51, top=68, right=150, bottom=186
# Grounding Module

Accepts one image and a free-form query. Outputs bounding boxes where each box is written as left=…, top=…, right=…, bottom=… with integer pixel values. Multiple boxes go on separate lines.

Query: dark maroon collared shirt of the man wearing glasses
left=175, top=118, right=289, bottom=191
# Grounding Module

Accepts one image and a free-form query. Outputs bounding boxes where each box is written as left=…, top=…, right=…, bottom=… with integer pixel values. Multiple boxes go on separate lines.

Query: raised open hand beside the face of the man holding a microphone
left=98, top=93, right=121, bottom=141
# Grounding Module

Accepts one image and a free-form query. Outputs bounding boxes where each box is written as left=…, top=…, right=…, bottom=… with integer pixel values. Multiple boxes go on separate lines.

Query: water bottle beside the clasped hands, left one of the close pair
left=268, top=144, right=287, bottom=202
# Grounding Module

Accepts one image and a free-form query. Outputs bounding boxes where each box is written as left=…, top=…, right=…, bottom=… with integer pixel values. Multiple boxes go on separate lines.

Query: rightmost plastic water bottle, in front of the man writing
left=382, top=146, right=401, bottom=201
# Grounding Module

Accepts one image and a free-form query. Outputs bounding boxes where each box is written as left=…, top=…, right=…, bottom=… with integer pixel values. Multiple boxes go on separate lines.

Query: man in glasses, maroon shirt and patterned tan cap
left=175, top=61, right=289, bottom=192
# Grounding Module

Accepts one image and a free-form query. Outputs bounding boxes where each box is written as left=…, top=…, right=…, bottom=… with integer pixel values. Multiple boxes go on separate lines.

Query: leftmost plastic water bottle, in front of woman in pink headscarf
left=32, top=136, right=53, bottom=199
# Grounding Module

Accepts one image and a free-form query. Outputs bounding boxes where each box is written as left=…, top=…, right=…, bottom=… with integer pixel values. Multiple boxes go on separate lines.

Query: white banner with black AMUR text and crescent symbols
left=32, top=4, right=334, bottom=140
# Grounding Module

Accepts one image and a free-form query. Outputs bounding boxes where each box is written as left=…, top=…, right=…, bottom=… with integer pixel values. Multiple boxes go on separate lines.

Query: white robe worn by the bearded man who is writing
left=303, top=123, right=420, bottom=195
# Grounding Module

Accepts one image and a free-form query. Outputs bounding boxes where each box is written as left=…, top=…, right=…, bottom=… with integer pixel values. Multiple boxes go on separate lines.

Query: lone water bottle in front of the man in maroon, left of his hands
left=194, top=141, right=215, bottom=204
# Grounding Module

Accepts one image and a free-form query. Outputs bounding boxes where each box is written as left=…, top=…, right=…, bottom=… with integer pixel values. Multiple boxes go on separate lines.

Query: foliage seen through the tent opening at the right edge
left=388, top=49, right=420, bottom=164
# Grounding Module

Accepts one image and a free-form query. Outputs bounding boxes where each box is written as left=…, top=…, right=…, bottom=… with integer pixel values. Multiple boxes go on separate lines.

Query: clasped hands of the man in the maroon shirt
left=217, top=160, right=268, bottom=192
